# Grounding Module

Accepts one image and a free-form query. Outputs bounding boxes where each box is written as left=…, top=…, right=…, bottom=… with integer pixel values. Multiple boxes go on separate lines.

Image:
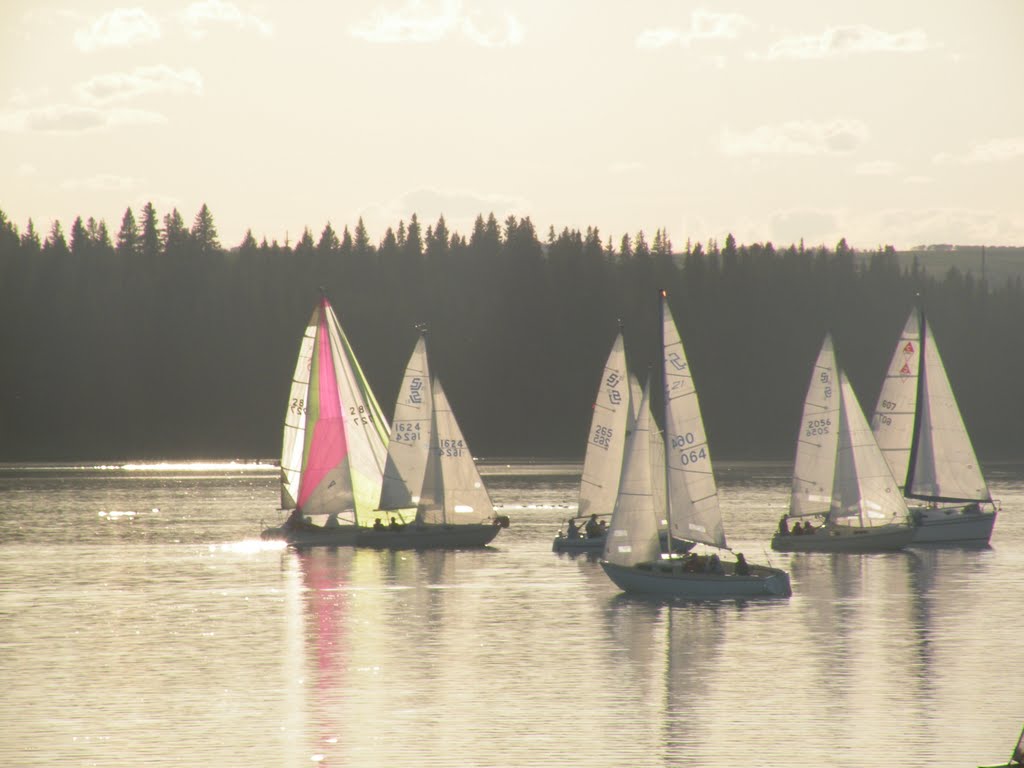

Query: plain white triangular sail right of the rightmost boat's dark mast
left=905, top=322, right=991, bottom=502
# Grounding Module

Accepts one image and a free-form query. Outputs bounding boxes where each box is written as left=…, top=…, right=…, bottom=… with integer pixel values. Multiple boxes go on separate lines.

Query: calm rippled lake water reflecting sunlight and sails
left=0, top=463, right=1024, bottom=768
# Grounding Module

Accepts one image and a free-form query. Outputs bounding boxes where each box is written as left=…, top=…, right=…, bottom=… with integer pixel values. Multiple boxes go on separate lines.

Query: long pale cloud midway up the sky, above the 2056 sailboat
left=720, top=120, right=867, bottom=156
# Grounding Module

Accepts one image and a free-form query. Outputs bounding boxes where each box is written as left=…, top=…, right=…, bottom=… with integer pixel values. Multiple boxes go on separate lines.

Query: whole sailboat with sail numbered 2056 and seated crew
left=771, top=334, right=914, bottom=552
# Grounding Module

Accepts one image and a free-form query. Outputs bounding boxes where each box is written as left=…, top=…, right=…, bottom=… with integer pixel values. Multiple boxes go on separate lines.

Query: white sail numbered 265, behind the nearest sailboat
left=579, top=332, right=634, bottom=516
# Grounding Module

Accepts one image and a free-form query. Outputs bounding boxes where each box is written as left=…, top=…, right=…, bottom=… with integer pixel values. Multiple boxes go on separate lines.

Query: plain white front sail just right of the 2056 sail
left=829, top=371, right=907, bottom=527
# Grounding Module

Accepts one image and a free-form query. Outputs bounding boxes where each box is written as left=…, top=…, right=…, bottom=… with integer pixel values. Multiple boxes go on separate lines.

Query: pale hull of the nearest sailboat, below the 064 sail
left=601, top=560, right=793, bottom=600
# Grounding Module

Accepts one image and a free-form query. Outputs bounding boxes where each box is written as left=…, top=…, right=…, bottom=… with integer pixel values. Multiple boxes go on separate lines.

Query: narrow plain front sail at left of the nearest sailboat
left=604, top=387, right=660, bottom=566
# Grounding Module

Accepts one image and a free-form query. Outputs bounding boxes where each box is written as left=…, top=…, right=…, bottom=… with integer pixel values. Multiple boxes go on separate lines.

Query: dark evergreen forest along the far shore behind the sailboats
left=0, top=204, right=1024, bottom=461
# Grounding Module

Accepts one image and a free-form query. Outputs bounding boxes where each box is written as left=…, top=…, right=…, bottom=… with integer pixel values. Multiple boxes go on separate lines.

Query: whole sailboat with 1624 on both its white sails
left=356, top=331, right=508, bottom=549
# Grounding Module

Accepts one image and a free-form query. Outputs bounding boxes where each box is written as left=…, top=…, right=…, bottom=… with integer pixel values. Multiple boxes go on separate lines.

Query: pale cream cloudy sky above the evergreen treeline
left=0, top=0, right=1024, bottom=250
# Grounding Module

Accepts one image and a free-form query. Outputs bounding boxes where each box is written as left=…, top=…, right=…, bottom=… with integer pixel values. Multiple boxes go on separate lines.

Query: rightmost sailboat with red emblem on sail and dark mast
left=871, top=308, right=996, bottom=546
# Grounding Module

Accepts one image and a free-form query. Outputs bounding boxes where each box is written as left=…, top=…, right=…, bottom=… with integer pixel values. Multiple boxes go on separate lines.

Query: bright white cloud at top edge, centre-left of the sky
left=348, top=0, right=525, bottom=48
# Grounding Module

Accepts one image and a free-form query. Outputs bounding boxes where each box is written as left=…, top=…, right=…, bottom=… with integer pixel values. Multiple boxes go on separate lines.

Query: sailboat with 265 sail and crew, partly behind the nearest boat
left=551, top=331, right=639, bottom=553
